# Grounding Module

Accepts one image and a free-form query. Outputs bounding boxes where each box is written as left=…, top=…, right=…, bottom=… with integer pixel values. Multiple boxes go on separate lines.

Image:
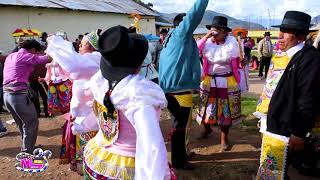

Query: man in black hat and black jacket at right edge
left=257, top=11, right=320, bottom=179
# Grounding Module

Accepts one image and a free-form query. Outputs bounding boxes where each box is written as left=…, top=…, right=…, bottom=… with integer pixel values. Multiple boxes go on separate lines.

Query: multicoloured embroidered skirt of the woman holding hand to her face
left=197, top=73, right=241, bottom=126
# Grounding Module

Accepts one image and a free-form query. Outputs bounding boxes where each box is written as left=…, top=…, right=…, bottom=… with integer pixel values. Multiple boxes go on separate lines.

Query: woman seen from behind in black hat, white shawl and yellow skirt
left=77, top=26, right=171, bottom=180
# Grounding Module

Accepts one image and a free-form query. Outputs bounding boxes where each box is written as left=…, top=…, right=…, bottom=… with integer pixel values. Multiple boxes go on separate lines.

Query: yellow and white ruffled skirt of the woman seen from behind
left=84, top=139, right=135, bottom=180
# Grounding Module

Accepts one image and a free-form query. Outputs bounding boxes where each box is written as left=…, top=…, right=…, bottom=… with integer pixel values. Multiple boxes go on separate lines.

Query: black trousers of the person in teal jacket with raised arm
left=166, top=94, right=191, bottom=168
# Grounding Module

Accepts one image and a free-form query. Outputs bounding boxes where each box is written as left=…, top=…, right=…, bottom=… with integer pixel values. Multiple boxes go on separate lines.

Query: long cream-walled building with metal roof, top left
left=0, top=0, right=159, bottom=54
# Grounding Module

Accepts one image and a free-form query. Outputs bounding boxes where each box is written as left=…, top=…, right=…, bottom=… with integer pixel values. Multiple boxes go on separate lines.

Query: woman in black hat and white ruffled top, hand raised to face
left=197, top=16, right=241, bottom=152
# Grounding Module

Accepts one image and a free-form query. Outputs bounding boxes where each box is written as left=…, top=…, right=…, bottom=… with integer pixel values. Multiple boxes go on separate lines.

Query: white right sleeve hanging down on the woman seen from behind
left=130, top=106, right=171, bottom=180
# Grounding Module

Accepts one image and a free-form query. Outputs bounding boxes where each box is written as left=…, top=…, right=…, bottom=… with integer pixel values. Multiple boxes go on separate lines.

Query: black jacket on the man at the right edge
left=267, top=45, right=320, bottom=138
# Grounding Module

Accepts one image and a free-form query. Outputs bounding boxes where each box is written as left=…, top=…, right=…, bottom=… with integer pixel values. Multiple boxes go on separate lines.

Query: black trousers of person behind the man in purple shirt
left=30, top=81, right=48, bottom=115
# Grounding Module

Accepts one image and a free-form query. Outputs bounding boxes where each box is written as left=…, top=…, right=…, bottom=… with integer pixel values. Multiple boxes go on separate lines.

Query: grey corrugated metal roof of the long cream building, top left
left=0, top=0, right=159, bottom=16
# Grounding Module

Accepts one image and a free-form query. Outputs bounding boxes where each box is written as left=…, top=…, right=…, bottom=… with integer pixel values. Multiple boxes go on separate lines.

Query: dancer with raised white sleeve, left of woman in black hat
left=47, top=32, right=101, bottom=172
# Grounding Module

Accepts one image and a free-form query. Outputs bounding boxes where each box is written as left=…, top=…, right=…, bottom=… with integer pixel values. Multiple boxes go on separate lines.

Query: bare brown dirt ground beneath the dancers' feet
left=0, top=75, right=316, bottom=180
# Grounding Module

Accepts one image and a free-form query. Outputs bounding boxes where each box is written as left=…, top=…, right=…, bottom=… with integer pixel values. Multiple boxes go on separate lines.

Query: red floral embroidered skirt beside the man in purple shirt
left=48, top=80, right=72, bottom=115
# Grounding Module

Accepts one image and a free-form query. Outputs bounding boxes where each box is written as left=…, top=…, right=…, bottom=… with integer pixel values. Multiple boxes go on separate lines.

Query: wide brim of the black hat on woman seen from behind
left=100, top=33, right=148, bottom=81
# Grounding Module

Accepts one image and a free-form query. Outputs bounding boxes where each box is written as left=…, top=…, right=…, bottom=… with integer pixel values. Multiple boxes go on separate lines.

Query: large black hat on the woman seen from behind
left=98, top=26, right=148, bottom=81
